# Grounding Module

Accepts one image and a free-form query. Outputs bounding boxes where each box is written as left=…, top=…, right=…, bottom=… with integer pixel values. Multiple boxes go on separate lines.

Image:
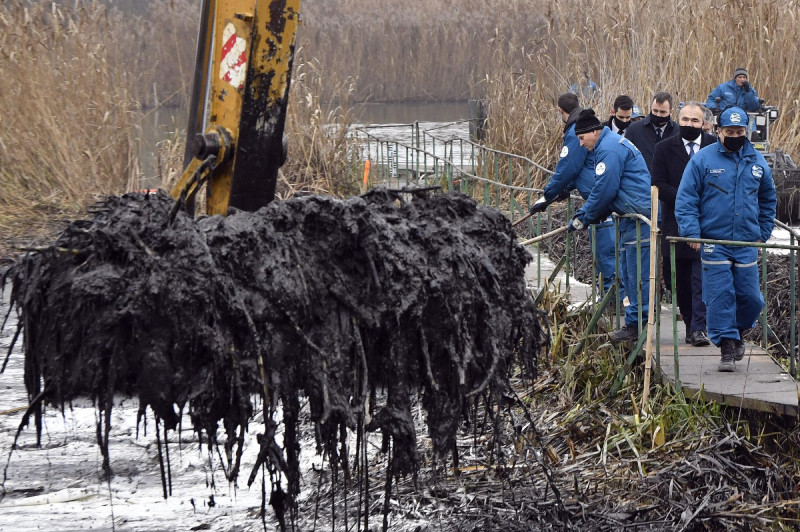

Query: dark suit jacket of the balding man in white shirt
left=650, top=133, right=717, bottom=259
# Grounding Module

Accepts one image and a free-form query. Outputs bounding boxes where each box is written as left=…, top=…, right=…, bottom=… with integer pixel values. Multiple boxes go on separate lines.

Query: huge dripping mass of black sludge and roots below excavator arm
left=3, top=189, right=547, bottom=522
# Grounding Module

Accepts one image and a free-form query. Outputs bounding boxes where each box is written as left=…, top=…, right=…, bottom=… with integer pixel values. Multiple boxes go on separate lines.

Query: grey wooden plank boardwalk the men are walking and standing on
left=525, top=246, right=800, bottom=418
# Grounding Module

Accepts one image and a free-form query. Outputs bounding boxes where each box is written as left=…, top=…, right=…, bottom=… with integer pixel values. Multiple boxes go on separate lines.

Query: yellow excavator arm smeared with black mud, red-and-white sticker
left=170, top=0, right=300, bottom=214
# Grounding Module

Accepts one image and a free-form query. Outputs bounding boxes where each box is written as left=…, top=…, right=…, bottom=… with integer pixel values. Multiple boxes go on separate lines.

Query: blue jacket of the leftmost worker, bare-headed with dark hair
left=543, top=123, right=594, bottom=201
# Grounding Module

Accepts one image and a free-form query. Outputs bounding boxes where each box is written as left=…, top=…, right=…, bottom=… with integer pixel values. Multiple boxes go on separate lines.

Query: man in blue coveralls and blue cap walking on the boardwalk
left=675, top=107, right=777, bottom=372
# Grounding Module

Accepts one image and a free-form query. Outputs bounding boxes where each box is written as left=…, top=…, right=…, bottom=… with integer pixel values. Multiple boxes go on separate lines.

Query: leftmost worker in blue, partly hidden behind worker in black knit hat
left=530, top=92, right=625, bottom=301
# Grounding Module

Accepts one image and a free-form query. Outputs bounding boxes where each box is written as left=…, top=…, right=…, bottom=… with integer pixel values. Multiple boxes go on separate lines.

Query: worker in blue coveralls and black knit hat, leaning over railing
left=568, top=109, right=650, bottom=342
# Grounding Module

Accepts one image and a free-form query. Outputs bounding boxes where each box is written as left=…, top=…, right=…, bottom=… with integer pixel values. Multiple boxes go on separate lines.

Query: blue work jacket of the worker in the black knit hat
left=577, top=127, right=650, bottom=224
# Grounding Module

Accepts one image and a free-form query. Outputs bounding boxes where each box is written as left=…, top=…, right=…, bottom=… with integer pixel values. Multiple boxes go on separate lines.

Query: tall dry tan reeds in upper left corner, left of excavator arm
left=0, top=0, right=138, bottom=249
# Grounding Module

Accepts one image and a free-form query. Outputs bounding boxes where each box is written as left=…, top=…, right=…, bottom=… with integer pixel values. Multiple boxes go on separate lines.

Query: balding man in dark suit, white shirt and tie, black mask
left=650, top=102, right=716, bottom=346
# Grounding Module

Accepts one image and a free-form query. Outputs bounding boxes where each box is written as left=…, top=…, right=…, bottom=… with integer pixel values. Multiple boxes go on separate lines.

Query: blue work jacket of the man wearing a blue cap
left=675, top=140, right=777, bottom=242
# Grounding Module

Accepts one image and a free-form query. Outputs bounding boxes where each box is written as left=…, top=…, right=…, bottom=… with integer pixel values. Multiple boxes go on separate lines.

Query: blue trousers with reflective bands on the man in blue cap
left=701, top=244, right=764, bottom=346
